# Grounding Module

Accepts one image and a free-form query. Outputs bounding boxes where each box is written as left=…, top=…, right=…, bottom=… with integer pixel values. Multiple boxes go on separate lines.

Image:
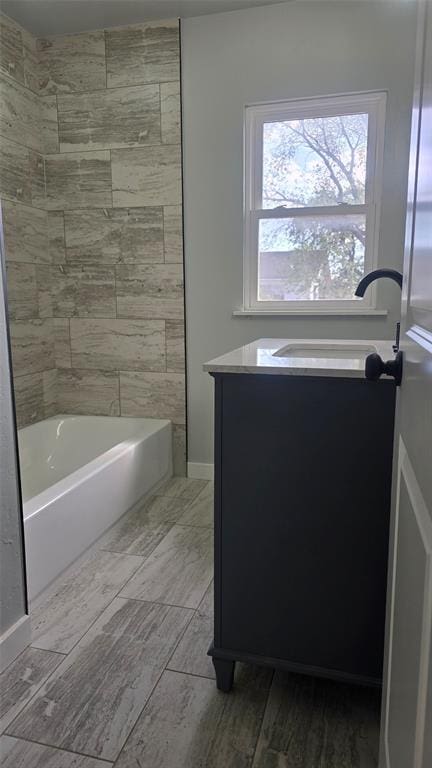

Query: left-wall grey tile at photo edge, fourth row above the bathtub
left=2, top=200, right=50, bottom=263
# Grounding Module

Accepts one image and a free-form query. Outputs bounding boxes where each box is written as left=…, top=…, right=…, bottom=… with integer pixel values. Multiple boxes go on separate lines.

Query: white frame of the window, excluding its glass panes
left=243, top=91, right=386, bottom=314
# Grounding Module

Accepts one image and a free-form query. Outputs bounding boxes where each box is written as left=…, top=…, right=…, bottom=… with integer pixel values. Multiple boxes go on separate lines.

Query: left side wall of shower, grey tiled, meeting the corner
left=0, top=16, right=58, bottom=425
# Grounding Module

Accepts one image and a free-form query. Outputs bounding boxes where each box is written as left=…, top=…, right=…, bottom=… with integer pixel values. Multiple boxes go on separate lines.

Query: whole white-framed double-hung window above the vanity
left=244, top=93, right=386, bottom=313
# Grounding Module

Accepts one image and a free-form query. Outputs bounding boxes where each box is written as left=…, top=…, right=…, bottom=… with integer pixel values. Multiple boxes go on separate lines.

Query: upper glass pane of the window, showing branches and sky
left=262, top=114, right=368, bottom=208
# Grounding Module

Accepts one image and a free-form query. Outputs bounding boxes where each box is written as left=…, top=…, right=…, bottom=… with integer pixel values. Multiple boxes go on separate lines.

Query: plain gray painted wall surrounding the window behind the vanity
left=182, top=2, right=415, bottom=463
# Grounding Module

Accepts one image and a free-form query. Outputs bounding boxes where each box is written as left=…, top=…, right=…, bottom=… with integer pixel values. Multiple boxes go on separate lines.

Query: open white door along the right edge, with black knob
left=380, top=0, right=432, bottom=768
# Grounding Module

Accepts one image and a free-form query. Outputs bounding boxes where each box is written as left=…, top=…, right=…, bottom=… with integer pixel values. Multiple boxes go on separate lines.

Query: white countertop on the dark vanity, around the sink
left=203, top=339, right=394, bottom=378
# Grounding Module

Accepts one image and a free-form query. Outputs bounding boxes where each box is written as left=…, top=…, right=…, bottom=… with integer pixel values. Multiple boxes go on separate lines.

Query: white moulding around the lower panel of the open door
left=384, top=437, right=432, bottom=768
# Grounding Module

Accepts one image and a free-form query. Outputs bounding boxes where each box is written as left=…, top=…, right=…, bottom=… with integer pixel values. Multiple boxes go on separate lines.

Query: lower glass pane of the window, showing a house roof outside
left=258, top=215, right=366, bottom=301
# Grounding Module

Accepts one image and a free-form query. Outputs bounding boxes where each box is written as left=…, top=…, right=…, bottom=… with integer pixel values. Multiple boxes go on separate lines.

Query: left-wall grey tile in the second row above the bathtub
left=10, top=320, right=55, bottom=373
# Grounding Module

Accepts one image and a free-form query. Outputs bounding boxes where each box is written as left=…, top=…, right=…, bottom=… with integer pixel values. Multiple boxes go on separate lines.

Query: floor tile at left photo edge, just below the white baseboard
left=0, top=648, right=64, bottom=733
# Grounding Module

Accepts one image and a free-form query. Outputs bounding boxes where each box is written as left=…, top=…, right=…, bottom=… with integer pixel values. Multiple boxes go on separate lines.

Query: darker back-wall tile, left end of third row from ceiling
left=45, top=151, right=112, bottom=210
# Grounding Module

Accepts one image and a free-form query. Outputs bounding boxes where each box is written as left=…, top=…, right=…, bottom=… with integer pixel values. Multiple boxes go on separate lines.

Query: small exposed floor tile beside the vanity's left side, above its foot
left=167, top=613, right=215, bottom=679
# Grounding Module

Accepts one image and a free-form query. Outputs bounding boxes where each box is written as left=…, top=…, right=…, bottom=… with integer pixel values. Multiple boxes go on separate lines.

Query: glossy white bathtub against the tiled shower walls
left=18, top=416, right=172, bottom=599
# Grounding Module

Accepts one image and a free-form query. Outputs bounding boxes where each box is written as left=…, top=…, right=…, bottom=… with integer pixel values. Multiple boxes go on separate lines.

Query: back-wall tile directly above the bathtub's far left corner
left=57, top=368, right=120, bottom=416
